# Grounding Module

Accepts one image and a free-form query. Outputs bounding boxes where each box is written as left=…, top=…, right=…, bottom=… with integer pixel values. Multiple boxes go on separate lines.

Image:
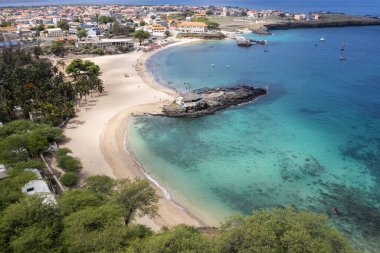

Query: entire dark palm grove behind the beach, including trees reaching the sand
left=0, top=48, right=103, bottom=125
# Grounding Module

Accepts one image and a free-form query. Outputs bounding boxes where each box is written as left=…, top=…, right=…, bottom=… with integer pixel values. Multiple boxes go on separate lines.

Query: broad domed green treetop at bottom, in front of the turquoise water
left=218, top=208, right=353, bottom=253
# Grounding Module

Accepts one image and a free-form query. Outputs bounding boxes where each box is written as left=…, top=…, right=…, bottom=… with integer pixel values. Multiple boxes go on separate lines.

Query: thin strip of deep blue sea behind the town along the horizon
left=0, top=0, right=380, bottom=16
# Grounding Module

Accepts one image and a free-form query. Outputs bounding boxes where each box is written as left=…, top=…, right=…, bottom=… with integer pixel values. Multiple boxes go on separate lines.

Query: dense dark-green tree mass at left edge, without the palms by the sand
left=0, top=48, right=74, bottom=125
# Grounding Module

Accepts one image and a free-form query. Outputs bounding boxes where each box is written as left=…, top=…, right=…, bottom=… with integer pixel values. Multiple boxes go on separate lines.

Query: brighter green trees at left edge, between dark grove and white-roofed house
left=0, top=120, right=64, bottom=212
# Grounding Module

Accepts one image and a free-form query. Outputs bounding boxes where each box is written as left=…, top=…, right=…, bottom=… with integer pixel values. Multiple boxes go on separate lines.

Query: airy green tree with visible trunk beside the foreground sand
left=114, top=178, right=159, bottom=225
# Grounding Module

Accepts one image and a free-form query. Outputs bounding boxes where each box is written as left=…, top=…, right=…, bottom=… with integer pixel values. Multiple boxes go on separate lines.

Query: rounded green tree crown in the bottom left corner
left=0, top=196, right=62, bottom=253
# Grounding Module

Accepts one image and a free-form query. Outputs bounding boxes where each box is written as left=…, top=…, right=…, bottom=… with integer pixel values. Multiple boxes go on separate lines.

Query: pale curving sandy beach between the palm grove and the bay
left=64, top=39, right=216, bottom=230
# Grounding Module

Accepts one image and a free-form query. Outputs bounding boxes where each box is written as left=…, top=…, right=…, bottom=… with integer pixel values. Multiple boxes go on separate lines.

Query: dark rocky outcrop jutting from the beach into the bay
left=162, top=85, right=267, bottom=118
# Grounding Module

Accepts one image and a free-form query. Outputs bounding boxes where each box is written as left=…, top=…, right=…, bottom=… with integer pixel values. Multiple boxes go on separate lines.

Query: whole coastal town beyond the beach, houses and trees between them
left=0, top=5, right=326, bottom=56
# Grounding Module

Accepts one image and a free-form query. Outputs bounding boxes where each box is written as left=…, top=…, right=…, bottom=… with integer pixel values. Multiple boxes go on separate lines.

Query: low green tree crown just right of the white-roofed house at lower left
left=59, top=189, right=105, bottom=216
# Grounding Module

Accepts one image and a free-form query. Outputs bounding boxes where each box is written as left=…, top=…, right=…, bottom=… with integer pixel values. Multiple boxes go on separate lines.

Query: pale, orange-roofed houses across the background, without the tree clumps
left=0, top=4, right=319, bottom=47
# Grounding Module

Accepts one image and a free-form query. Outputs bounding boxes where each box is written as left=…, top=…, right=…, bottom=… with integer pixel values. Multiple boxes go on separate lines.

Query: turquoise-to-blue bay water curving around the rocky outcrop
left=129, top=27, right=380, bottom=252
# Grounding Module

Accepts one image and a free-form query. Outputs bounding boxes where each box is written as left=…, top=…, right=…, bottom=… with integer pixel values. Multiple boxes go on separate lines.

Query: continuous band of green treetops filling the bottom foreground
left=0, top=160, right=360, bottom=253
